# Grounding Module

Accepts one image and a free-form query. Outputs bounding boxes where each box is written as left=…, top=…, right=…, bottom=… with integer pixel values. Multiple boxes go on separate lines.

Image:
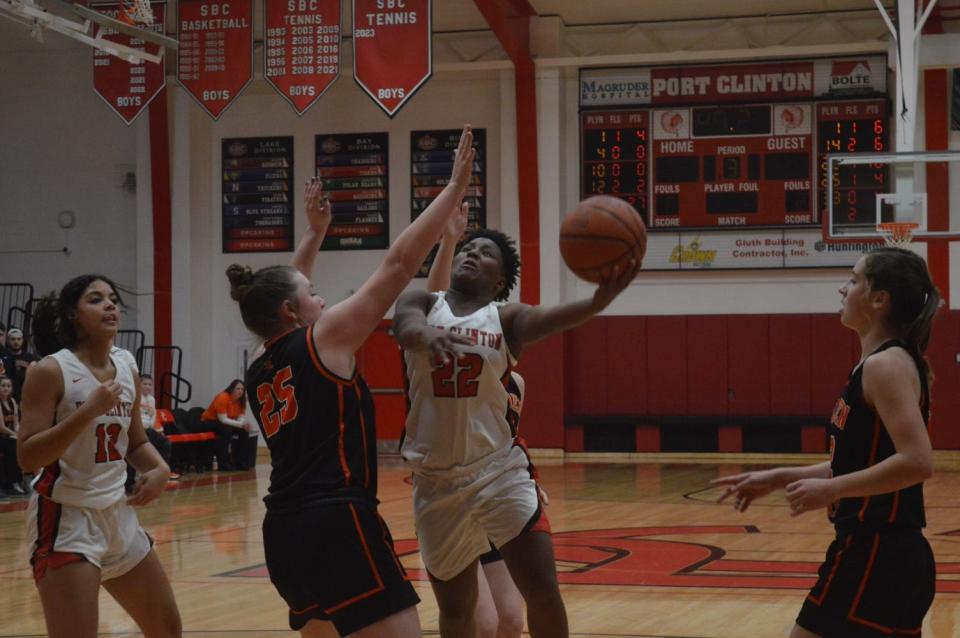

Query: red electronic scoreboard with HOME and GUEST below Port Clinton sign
left=580, top=99, right=890, bottom=230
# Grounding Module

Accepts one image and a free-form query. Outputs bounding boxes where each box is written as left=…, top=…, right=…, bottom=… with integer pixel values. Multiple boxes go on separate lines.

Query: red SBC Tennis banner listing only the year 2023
left=353, top=0, right=433, bottom=117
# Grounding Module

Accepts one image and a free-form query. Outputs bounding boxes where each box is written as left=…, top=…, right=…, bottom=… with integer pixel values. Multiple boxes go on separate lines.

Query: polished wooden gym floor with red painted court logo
left=0, top=458, right=960, bottom=638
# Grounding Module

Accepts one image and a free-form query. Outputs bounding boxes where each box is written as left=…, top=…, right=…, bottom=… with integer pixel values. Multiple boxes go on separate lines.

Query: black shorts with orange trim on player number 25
left=263, top=502, right=420, bottom=636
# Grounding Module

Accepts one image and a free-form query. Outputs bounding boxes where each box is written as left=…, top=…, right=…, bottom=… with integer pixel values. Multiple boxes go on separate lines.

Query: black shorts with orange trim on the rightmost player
left=797, top=530, right=936, bottom=638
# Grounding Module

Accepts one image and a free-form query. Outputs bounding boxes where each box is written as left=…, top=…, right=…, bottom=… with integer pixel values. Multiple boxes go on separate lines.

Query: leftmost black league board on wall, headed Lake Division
left=222, top=137, right=294, bottom=253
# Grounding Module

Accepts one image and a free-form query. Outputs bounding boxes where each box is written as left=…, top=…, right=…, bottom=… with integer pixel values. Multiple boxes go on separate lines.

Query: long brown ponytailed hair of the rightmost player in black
left=864, top=246, right=941, bottom=376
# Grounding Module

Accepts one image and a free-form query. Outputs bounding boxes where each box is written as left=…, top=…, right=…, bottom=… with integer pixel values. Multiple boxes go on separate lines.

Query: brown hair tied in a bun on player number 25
left=227, top=264, right=297, bottom=339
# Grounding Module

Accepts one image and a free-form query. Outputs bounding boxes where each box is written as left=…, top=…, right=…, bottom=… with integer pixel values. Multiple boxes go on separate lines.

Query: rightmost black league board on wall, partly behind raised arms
left=410, top=128, right=487, bottom=277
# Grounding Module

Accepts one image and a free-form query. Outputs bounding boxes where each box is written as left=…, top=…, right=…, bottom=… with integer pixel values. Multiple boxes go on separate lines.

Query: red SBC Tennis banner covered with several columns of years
left=263, top=0, right=340, bottom=115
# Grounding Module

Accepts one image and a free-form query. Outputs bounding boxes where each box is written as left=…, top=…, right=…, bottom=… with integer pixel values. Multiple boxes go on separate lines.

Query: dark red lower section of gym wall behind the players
left=358, top=311, right=960, bottom=452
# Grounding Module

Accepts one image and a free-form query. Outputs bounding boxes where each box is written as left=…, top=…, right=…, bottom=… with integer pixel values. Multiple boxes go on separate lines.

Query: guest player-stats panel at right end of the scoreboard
left=817, top=100, right=892, bottom=227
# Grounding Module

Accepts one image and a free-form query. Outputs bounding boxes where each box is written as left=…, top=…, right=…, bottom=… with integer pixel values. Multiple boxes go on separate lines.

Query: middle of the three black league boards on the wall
left=316, top=133, right=390, bottom=250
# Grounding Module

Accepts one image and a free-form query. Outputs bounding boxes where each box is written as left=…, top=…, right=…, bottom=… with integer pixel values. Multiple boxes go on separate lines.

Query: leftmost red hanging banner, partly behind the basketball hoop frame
left=91, top=2, right=167, bottom=125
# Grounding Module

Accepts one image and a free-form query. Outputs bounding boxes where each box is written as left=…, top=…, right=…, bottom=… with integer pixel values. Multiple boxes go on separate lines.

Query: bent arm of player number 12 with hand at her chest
left=17, top=357, right=122, bottom=473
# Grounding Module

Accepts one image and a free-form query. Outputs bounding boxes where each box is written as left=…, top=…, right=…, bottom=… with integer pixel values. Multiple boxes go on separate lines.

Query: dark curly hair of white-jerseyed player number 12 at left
left=30, top=274, right=123, bottom=357
